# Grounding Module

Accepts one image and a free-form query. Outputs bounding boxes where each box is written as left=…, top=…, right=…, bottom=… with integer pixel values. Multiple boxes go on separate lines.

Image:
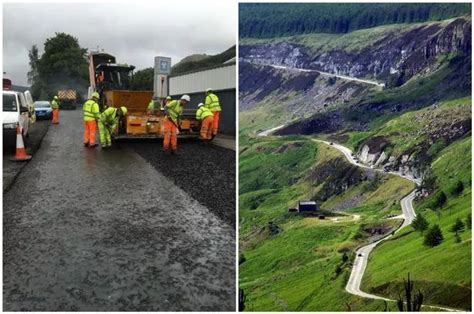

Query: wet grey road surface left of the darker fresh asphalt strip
left=3, top=110, right=235, bottom=311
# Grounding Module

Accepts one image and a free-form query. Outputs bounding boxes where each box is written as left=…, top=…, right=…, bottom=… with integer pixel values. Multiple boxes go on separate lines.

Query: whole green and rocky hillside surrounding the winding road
left=239, top=3, right=472, bottom=311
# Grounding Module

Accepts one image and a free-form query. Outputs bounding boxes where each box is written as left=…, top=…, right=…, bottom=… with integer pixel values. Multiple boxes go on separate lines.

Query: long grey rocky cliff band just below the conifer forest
left=239, top=18, right=471, bottom=84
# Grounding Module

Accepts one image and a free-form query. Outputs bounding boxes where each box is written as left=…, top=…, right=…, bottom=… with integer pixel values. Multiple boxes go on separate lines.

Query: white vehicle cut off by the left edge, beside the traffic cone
left=3, top=91, right=30, bottom=143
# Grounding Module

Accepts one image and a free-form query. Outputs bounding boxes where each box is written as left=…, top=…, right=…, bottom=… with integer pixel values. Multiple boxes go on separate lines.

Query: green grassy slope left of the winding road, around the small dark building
left=239, top=137, right=412, bottom=311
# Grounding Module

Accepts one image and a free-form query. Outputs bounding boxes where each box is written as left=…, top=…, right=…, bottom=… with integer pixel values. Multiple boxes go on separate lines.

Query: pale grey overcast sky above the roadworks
left=3, top=0, right=237, bottom=85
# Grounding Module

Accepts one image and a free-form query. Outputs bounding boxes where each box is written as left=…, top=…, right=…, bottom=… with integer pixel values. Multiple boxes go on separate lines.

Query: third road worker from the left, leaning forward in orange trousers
left=163, top=95, right=191, bottom=155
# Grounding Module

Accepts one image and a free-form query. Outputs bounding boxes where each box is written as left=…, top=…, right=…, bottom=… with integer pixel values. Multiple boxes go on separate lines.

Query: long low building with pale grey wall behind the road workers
left=169, top=59, right=237, bottom=136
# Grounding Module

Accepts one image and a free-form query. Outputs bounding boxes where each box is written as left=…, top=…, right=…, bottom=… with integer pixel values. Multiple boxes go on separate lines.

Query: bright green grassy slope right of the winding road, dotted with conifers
left=363, top=137, right=471, bottom=310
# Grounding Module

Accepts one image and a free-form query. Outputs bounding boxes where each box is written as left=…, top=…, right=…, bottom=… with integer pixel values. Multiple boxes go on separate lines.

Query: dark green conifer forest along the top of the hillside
left=239, top=3, right=471, bottom=38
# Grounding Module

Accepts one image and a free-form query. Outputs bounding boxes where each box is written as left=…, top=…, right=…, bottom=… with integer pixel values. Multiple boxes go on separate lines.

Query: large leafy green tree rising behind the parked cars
left=32, top=33, right=89, bottom=98
